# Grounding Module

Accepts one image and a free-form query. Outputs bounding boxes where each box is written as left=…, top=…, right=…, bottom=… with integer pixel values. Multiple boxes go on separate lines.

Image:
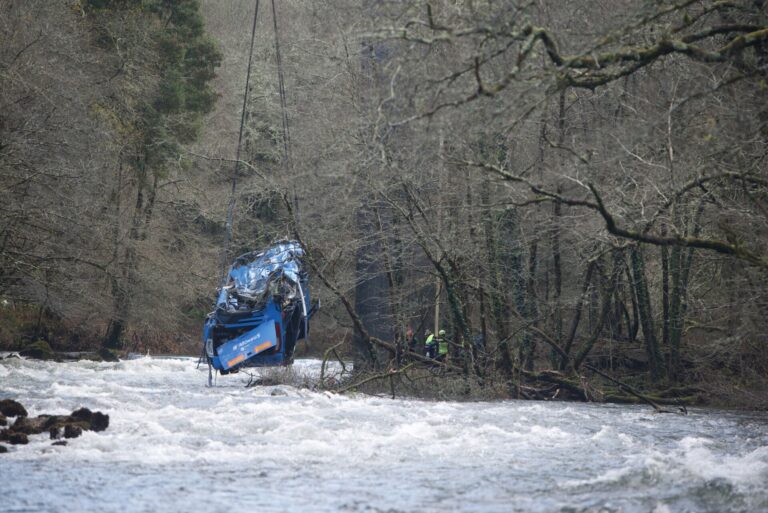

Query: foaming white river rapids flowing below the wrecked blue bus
left=0, top=358, right=768, bottom=513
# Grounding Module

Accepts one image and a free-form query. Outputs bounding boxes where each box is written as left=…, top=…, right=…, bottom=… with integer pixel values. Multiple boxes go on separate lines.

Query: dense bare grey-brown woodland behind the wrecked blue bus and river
left=0, top=0, right=768, bottom=403
